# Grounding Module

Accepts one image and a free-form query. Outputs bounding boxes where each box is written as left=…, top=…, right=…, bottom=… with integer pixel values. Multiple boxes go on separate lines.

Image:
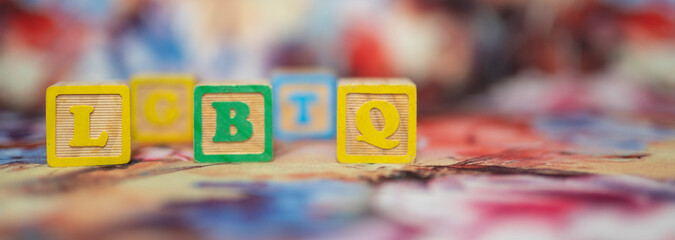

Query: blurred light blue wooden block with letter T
left=272, top=71, right=336, bottom=141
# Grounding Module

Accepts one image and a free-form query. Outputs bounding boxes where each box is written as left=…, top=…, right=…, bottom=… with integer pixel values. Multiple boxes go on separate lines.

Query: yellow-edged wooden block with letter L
left=46, top=82, right=131, bottom=167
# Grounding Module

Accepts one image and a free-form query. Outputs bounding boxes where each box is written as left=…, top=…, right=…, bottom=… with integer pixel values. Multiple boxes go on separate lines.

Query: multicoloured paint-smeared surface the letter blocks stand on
left=0, top=114, right=675, bottom=239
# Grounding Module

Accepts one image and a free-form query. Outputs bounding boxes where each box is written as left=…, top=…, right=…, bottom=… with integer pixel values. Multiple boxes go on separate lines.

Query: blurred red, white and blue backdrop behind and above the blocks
left=0, top=0, right=675, bottom=114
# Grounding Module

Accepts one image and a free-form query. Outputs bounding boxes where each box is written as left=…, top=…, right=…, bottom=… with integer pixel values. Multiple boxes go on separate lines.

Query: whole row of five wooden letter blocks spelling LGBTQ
left=46, top=72, right=417, bottom=167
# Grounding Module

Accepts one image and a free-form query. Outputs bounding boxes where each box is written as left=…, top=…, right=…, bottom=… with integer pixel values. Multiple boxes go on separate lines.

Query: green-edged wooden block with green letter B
left=194, top=83, right=272, bottom=162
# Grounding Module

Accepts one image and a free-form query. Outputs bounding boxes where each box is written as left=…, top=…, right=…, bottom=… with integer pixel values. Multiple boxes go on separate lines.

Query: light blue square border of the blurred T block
left=272, top=73, right=337, bottom=141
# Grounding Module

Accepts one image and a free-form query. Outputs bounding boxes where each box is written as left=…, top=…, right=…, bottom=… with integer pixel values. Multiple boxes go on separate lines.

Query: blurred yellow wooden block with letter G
left=131, top=75, right=195, bottom=143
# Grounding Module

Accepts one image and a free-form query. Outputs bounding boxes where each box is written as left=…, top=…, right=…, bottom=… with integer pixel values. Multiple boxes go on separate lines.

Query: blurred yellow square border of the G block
left=131, top=75, right=196, bottom=143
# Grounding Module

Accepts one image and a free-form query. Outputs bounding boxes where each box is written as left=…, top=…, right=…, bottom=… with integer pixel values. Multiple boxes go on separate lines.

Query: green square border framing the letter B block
left=194, top=85, right=273, bottom=163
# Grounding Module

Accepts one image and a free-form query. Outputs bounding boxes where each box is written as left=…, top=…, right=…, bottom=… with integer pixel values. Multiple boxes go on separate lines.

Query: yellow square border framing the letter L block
left=46, top=85, right=131, bottom=167
